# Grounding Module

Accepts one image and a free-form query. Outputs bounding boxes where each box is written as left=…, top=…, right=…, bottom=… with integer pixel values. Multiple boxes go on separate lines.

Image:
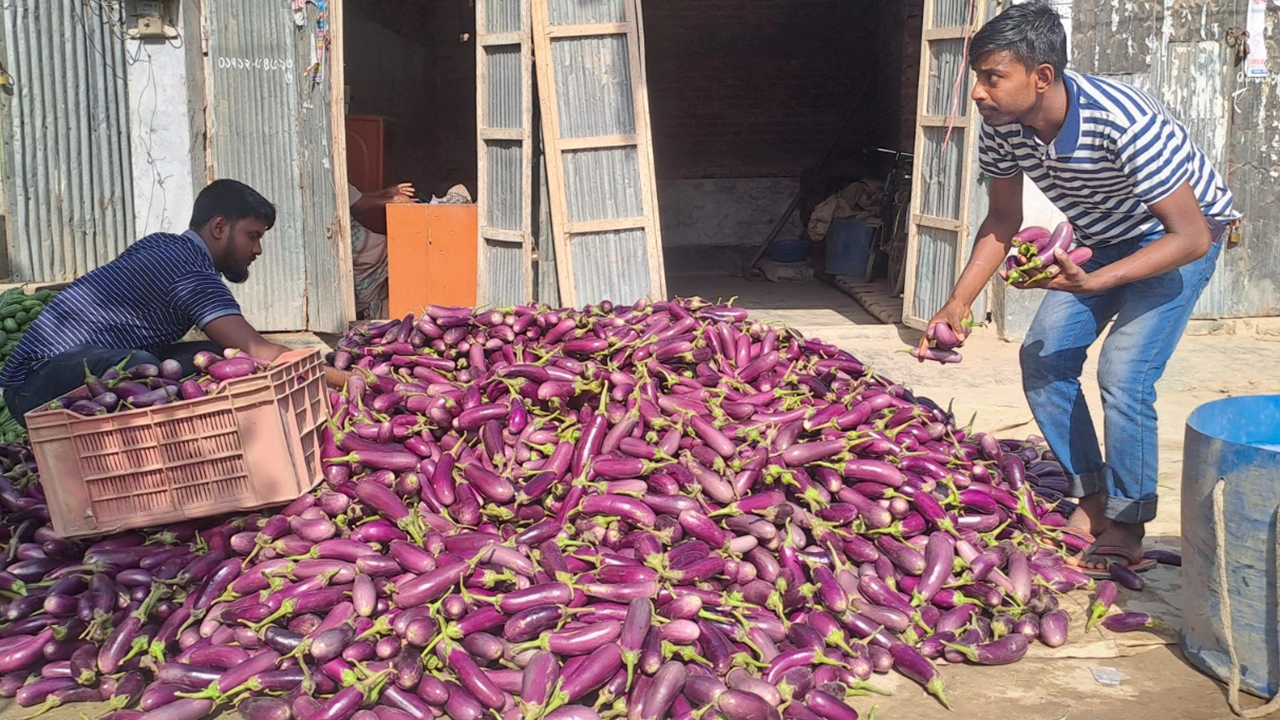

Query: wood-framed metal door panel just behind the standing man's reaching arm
left=902, top=0, right=986, bottom=329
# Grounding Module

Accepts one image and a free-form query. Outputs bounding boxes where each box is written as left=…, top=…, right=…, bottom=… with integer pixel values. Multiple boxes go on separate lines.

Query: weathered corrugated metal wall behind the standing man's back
left=1073, top=0, right=1280, bottom=318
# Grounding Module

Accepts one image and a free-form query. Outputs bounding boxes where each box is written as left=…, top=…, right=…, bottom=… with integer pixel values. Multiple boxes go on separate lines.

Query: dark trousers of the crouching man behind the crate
left=4, top=341, right=223, bottom=428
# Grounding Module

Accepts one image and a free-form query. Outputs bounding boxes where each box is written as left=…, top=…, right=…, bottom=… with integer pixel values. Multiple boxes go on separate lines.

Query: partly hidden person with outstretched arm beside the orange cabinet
left=347, top=182, right=415, bottom=320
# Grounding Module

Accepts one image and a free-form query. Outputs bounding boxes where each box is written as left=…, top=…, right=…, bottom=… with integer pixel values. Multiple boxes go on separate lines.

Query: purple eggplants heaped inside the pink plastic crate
left=46, top=347, right=269, bottom=416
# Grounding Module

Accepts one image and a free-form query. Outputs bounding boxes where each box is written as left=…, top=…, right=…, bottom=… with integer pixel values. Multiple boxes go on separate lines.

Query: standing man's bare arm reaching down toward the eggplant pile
left=922, top=172, right=1023, bottom=347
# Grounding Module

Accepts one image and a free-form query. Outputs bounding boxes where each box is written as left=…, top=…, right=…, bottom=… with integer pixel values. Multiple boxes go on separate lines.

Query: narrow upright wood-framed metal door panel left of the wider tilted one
left=476, top=0, right=534, bottom=306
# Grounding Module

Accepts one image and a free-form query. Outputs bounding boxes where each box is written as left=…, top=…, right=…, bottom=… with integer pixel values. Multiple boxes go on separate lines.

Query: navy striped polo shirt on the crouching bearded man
left=0, top=231, right=241, bottom=388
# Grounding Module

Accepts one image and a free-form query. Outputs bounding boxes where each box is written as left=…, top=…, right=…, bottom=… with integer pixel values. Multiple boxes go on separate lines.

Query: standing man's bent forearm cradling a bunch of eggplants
left=1025, top=182, right=1213, bottom=295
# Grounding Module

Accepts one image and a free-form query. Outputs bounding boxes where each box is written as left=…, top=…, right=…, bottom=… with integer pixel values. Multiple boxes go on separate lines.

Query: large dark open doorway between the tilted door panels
left=644, top=0, right=924, bottom=319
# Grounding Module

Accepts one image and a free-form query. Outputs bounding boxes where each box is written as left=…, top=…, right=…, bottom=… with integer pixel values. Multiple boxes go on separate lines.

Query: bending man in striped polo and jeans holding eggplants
left=931, top=0, right=1238, bottom=574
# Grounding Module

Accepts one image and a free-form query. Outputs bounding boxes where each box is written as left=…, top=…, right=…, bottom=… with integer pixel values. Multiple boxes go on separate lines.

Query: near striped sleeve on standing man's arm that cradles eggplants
left=1116, top=114, right=1194, bottom=208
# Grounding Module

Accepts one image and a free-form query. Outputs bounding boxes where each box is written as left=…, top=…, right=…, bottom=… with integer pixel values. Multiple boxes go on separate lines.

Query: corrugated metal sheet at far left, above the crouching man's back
left=0, top=0, right=134, bottom=282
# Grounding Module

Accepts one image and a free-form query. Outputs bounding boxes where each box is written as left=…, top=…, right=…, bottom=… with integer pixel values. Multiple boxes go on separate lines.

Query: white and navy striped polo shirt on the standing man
left=978, top=70, right=1239, bottom=245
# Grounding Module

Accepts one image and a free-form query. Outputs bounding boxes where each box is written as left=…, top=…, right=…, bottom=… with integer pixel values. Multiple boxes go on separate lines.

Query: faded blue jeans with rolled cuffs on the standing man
left=1020, top=220, right=1224, bottom=523
